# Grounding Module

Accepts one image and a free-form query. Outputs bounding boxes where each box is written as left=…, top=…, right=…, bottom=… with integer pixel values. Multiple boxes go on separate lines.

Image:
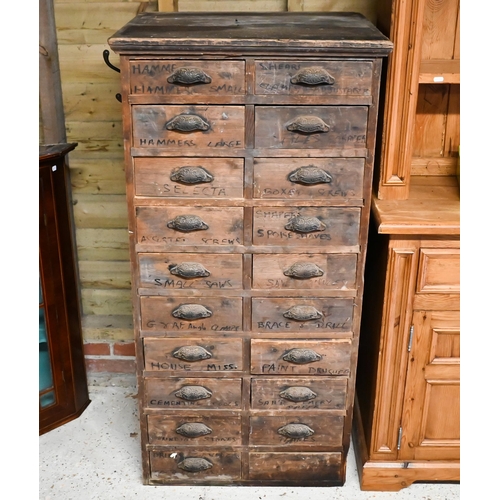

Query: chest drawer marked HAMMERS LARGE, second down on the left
left=132, top=105, right=245, bottom=152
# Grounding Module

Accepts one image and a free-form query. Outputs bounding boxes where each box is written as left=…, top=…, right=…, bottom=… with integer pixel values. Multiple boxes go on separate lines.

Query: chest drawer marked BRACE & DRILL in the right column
left=252, top=297, right=354, bottom=333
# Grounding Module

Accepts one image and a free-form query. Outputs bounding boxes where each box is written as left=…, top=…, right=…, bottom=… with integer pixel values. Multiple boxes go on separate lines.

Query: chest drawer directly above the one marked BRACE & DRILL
left=252, top=254, right=358, bottom=292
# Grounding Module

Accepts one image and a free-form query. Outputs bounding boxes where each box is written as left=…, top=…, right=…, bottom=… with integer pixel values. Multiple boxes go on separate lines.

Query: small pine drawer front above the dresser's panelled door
left=417, top=248, right=460, bottom=293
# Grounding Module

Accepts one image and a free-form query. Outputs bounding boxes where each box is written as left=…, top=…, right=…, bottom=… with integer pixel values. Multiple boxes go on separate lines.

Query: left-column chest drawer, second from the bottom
left=147, top=413, right=241, bottom=446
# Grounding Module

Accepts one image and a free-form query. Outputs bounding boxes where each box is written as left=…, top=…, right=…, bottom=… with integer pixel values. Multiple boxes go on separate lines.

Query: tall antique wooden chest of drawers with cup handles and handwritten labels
left=109, top=13, right=392, bottom=486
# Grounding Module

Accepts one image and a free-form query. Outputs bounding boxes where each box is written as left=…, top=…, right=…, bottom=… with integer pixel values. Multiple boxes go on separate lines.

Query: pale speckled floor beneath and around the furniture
left=39, top=379, right=460, bottom=500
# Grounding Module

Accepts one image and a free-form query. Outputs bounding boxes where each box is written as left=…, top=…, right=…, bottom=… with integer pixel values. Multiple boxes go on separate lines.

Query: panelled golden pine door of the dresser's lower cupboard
left=399, top=311, right=460, bottom=460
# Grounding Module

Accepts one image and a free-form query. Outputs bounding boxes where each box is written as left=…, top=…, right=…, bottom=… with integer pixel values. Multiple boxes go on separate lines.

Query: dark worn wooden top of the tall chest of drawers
left=108, top=12, right=392, bottom=55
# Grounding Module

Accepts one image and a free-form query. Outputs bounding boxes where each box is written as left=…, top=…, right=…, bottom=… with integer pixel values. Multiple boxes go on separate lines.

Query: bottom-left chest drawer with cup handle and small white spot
left=149, top=447, right=241, bottom=484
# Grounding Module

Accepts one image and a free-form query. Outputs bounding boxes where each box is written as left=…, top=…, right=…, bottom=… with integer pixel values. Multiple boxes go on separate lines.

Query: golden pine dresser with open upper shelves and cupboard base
left=353, top=0, right=460, bottom=491
